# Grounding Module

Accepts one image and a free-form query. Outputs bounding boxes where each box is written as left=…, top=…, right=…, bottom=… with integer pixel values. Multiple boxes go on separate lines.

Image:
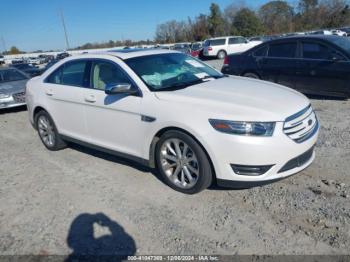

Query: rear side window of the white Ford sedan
left=47, top=61, right=89, bottom=87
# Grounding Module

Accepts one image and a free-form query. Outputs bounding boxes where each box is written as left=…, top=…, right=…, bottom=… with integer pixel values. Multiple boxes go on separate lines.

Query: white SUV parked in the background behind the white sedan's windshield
left=203, top=36, right=261, bottom=59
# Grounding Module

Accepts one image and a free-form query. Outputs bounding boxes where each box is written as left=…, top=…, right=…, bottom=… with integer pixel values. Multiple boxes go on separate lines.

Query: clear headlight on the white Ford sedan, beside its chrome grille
left=209, top=119, right=275, bottom=136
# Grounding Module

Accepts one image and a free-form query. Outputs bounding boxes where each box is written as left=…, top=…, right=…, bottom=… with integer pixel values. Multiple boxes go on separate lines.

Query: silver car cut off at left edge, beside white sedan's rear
left=0, top=67, right=29, bottom=109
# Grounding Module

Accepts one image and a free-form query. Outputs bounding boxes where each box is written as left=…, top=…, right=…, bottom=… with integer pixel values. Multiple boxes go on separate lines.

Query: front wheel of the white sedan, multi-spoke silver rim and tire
left=155, top=130, right=213, bottom=194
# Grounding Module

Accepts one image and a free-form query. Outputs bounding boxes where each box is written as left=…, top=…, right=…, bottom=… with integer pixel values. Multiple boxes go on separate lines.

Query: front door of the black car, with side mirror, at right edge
left=296, top=40, right=350, bottom=96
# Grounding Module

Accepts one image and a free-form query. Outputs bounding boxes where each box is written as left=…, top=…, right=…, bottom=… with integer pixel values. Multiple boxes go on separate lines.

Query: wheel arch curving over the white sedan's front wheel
left=149, top=126, right=216, bottom=182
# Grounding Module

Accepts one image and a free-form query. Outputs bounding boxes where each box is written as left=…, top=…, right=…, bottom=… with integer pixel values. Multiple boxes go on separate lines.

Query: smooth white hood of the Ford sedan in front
left=155, top=77, right=310, bottom=122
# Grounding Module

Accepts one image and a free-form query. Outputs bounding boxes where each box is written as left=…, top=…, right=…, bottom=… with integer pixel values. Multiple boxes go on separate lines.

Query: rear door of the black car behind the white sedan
left=259, top=41, right=298, bottom=88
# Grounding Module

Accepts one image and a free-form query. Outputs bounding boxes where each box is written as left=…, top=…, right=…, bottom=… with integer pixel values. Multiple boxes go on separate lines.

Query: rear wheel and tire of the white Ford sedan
left=35, top=110, right=67, bottom=151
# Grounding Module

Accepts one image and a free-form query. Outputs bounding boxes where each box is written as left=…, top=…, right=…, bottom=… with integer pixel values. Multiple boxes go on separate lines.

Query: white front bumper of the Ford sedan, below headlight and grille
left=210, top=122, right=319, bottom=186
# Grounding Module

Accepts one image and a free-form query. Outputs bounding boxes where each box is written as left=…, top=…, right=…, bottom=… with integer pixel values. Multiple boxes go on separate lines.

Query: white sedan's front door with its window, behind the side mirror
left=84, top=60, right=144, bottom=156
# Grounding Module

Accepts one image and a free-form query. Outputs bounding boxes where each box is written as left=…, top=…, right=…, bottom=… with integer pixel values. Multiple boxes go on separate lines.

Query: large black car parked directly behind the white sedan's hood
left=222, top=35, right=350, bottom=97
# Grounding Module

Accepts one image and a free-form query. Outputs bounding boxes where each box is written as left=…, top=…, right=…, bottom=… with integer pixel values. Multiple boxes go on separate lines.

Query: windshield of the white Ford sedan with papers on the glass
left=125, top=53, right=223, bottom=91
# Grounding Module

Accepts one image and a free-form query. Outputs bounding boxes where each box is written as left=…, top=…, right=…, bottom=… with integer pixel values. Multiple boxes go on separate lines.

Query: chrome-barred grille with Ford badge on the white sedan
left=283, top=105, right=318, bottom=143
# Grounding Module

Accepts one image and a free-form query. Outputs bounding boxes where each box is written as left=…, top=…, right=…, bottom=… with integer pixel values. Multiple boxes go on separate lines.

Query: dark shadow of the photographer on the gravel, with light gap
left=66, top=213, right=136, bottom=262
